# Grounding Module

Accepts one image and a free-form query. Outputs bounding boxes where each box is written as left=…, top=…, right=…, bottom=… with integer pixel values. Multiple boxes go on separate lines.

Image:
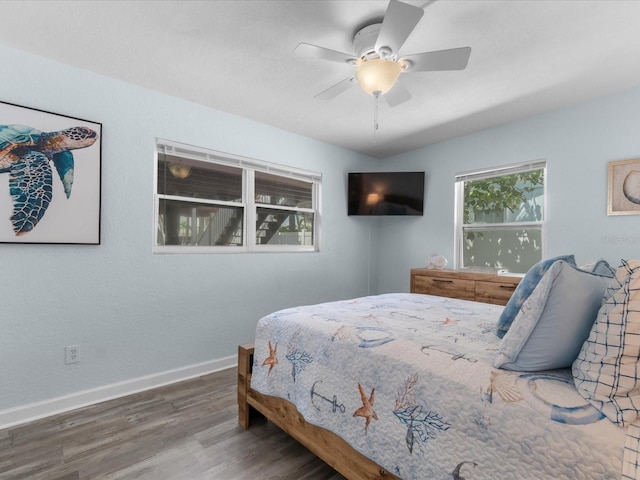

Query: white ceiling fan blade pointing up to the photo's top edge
left=375, top=0, right=424, bottom=55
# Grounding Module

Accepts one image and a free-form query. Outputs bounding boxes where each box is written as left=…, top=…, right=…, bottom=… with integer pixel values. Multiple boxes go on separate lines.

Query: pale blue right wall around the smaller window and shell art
left=376, top=88, right=640, bottom=293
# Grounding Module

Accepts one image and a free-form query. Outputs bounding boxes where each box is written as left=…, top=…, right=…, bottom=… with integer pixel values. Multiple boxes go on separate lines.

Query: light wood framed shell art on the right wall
left=607, top=158, right=640, bottom=215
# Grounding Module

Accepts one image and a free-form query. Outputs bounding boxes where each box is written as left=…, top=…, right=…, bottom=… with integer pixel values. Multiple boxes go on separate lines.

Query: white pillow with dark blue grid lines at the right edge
left=572, top=260, right=640, bottom=426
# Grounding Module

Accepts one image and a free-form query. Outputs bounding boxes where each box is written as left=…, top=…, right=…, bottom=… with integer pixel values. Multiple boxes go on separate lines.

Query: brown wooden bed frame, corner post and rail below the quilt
left=238, top=344, right=400, bottom=480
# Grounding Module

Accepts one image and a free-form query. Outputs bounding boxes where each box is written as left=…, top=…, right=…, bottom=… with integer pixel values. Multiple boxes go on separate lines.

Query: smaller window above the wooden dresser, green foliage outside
left=455, top=160, right=546, bottom=273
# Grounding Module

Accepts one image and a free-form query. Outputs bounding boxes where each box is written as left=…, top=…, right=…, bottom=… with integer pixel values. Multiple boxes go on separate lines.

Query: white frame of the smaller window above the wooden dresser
left=454, top=159, right=548, bottom=268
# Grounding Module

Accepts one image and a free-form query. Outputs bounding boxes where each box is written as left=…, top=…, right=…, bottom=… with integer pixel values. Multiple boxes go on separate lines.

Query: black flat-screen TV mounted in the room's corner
left=348, top=172, right=424, bottom=215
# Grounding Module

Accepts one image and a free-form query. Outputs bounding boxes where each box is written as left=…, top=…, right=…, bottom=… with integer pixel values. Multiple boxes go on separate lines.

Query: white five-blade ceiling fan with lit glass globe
left=294, top=0, right=471, bottom=107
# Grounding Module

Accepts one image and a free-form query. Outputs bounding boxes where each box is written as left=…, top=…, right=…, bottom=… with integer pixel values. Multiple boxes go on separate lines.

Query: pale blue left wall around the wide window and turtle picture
left=0, top=47, right=372, bottom=411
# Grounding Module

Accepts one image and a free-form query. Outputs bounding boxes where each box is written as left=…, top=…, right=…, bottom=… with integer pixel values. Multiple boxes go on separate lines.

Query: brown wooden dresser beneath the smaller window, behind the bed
left=411, top=268, right=521, bottom=305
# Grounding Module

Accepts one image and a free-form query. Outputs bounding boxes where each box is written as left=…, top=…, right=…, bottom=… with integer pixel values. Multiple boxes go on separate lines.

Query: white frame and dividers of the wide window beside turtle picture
left=152, top=138, right=322, bottom=254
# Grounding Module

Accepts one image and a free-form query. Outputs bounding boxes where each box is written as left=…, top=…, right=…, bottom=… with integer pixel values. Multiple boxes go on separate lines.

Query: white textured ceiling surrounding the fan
left=0, top=0, right=640, bottom=158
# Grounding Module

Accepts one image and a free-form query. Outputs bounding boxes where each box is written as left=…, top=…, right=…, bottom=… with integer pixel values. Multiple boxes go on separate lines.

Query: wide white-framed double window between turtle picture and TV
left=154, top=140, right=321, bottom=253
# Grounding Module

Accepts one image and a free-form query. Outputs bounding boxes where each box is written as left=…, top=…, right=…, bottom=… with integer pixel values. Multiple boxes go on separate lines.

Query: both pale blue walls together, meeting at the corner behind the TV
left=0, top=41, right=640, bottom=411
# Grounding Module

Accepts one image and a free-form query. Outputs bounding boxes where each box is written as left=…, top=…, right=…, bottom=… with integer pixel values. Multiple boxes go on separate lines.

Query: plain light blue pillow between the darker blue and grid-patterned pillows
left=493, top=260, right=611, bottom=372
